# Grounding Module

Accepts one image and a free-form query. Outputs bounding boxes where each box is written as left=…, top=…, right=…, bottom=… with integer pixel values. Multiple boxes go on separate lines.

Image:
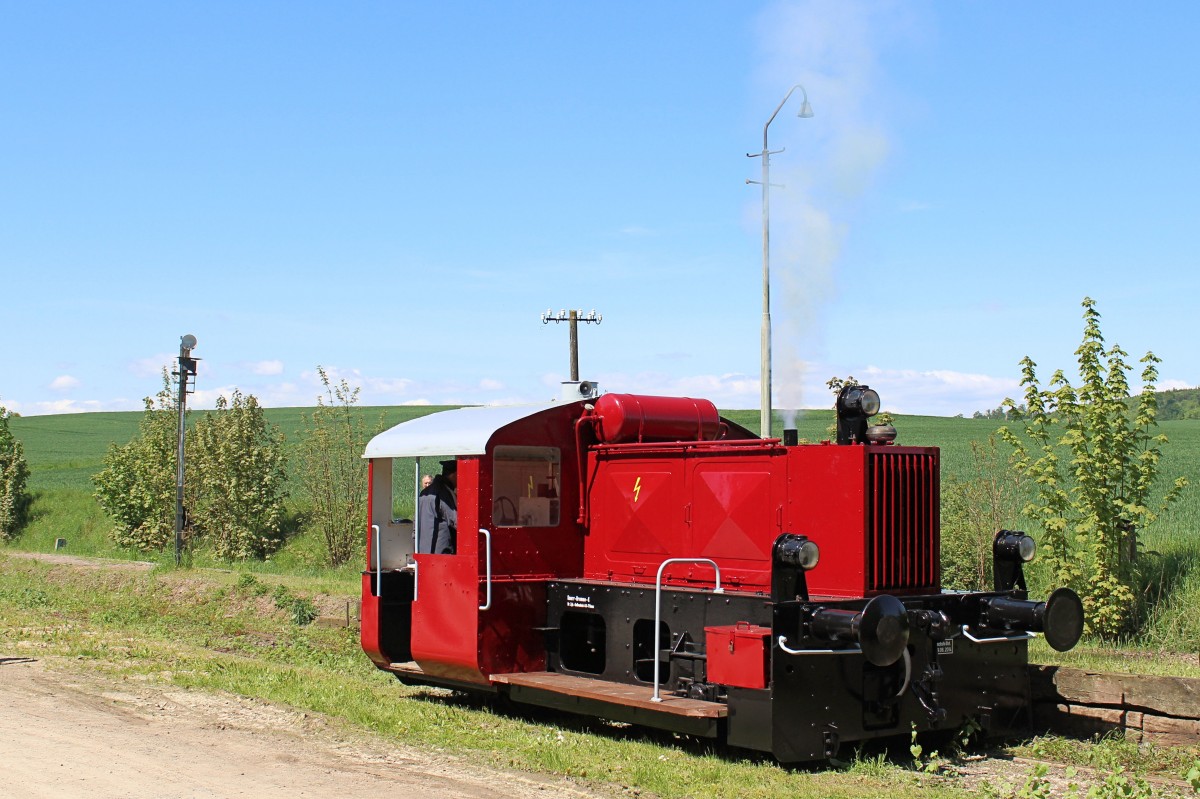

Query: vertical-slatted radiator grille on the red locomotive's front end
left=866, top=450, right=941, bottom=591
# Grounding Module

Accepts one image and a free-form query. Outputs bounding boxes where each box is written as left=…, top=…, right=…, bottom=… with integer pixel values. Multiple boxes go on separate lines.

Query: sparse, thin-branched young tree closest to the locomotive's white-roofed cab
left=299, top=366, right=367, bottom=566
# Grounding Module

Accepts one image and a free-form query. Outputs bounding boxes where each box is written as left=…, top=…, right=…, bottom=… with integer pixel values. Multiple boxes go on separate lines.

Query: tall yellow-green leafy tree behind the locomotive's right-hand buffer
left=1000, top=298, right=1187, bottom=638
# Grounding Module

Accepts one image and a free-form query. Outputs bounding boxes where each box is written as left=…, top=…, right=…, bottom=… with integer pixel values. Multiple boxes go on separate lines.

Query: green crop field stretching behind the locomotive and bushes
left=4, top=407, right=1200, bottom=661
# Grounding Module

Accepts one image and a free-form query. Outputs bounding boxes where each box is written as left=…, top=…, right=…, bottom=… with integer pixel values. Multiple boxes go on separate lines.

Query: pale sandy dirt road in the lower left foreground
left=0, top=653, right=606, bottom=799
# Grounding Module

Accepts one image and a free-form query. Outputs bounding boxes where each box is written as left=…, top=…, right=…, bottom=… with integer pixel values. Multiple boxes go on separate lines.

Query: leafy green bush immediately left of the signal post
left=92, top=370, right=177, bottom=552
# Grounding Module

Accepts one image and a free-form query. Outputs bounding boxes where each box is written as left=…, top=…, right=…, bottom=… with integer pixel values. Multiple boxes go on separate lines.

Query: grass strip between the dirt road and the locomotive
left=0, top=553, right=967, bottom=799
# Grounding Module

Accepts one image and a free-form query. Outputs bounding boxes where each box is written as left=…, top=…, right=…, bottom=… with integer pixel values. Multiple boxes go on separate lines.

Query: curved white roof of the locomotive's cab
left=362, top=402, right=564, bottom=458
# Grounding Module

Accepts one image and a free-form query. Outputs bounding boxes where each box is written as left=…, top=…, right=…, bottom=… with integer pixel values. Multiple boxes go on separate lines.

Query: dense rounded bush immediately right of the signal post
left=188, top=389, right=287, bottom=560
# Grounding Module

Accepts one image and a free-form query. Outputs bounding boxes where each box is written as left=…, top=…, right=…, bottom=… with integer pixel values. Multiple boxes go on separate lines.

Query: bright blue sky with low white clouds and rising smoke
left=0, top=0, right=1200, bottom=415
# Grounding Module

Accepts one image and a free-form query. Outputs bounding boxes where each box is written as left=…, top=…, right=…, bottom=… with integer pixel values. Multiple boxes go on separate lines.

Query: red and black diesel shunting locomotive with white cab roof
left=361, top=383, right=1084, bottom=763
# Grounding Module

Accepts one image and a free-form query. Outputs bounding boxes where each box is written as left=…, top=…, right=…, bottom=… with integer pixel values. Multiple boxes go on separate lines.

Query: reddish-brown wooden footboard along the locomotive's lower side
left=388, top=662, right=728, bottom=738
